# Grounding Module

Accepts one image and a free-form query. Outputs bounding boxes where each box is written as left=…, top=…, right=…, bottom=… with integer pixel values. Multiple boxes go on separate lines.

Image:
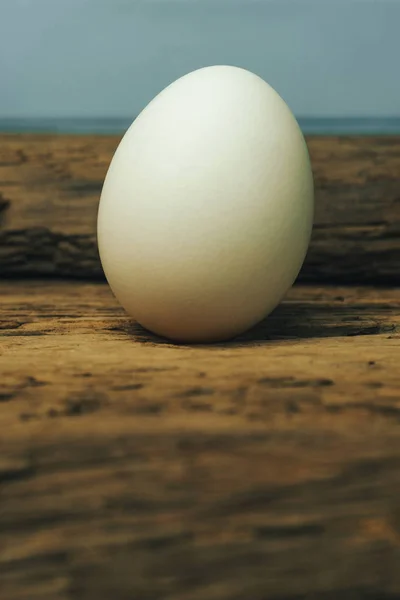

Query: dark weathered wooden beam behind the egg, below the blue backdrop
left=0, top=135, right=400, bottom=283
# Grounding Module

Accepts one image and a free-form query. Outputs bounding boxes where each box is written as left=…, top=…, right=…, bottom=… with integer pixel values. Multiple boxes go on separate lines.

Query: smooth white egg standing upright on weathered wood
left=98, top=66, right=314, bottom=342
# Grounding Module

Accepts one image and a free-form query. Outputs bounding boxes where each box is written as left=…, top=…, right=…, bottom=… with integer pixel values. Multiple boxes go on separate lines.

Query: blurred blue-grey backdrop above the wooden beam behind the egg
left=0, top=0, right=400, bottom=133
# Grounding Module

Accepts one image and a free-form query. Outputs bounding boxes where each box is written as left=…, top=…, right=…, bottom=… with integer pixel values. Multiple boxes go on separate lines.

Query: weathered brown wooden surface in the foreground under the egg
left=0, top=281, right=400, bottom=600
